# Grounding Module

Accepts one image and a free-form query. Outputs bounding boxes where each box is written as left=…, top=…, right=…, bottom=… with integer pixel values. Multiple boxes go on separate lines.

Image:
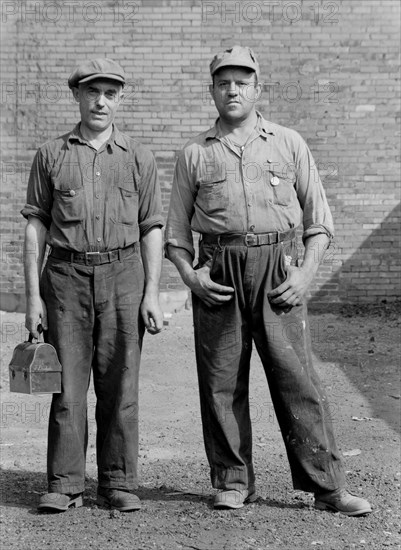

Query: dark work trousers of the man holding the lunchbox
left=41, top=249, right=144, bottom=494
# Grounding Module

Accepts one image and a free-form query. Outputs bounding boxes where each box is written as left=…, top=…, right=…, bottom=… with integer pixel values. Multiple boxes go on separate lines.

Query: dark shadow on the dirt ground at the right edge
left=310, top=301, right=401, bottom=433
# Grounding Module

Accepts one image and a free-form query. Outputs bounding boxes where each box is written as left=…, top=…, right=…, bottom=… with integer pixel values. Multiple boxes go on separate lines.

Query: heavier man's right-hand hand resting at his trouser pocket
left=267, top=265, right=313, bottom=308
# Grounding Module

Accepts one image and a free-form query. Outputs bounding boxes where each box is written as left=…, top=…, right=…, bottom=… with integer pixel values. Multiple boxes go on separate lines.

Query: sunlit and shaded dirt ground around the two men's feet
left=0, top=304, right=401, bottom=550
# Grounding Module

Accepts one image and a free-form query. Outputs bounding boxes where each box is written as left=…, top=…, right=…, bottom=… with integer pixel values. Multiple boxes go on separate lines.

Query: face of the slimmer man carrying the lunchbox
left=73, top=78, right=124, bottom=132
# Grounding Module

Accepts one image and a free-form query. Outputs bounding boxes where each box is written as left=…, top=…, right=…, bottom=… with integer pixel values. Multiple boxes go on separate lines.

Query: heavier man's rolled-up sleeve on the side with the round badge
left=296, top=138, right=334, bottom=242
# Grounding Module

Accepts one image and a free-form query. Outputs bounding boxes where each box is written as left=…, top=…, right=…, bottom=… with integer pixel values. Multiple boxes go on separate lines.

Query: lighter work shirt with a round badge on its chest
left=166, top=113, right=334, bottom=256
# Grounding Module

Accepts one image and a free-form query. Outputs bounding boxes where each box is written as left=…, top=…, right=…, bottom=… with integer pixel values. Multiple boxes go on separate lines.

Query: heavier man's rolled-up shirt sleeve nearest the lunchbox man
left=165, top=149, right=196, bottom=258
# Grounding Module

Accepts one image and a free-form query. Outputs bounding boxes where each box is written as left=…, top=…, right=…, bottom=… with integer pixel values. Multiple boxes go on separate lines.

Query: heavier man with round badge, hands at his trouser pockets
left=166, top=46, right=371, bottom=516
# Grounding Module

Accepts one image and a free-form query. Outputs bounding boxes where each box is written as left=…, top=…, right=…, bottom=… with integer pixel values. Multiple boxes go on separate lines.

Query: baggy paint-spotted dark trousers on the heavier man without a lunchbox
left=193, top=242, right=345, bottom=498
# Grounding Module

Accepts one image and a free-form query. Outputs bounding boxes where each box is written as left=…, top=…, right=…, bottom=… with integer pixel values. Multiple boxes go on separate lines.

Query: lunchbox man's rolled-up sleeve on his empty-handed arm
left=138, top=149, right=164, bottom=236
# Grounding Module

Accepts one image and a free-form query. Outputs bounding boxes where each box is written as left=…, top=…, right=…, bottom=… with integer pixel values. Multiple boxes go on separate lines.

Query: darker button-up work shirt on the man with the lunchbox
left=21, top=124, right=163, bottom=252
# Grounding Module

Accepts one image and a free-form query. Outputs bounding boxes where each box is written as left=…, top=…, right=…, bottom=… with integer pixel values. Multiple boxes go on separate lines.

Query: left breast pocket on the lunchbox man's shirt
left=52, top=184, right=85, bottom=224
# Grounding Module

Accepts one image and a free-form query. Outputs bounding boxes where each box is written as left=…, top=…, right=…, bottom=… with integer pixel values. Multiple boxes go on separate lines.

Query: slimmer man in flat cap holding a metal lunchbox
left=22, top=58, right=163, bottom=512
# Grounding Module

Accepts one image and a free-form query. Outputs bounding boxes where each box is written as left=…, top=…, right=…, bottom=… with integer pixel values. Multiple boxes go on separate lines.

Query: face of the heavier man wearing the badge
left=210, top=67, right=261, bottom=121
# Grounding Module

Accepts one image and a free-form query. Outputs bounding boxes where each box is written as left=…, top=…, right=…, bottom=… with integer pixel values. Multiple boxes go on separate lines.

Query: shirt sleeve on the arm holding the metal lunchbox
left=21, top=149, right=53, bottom=228
